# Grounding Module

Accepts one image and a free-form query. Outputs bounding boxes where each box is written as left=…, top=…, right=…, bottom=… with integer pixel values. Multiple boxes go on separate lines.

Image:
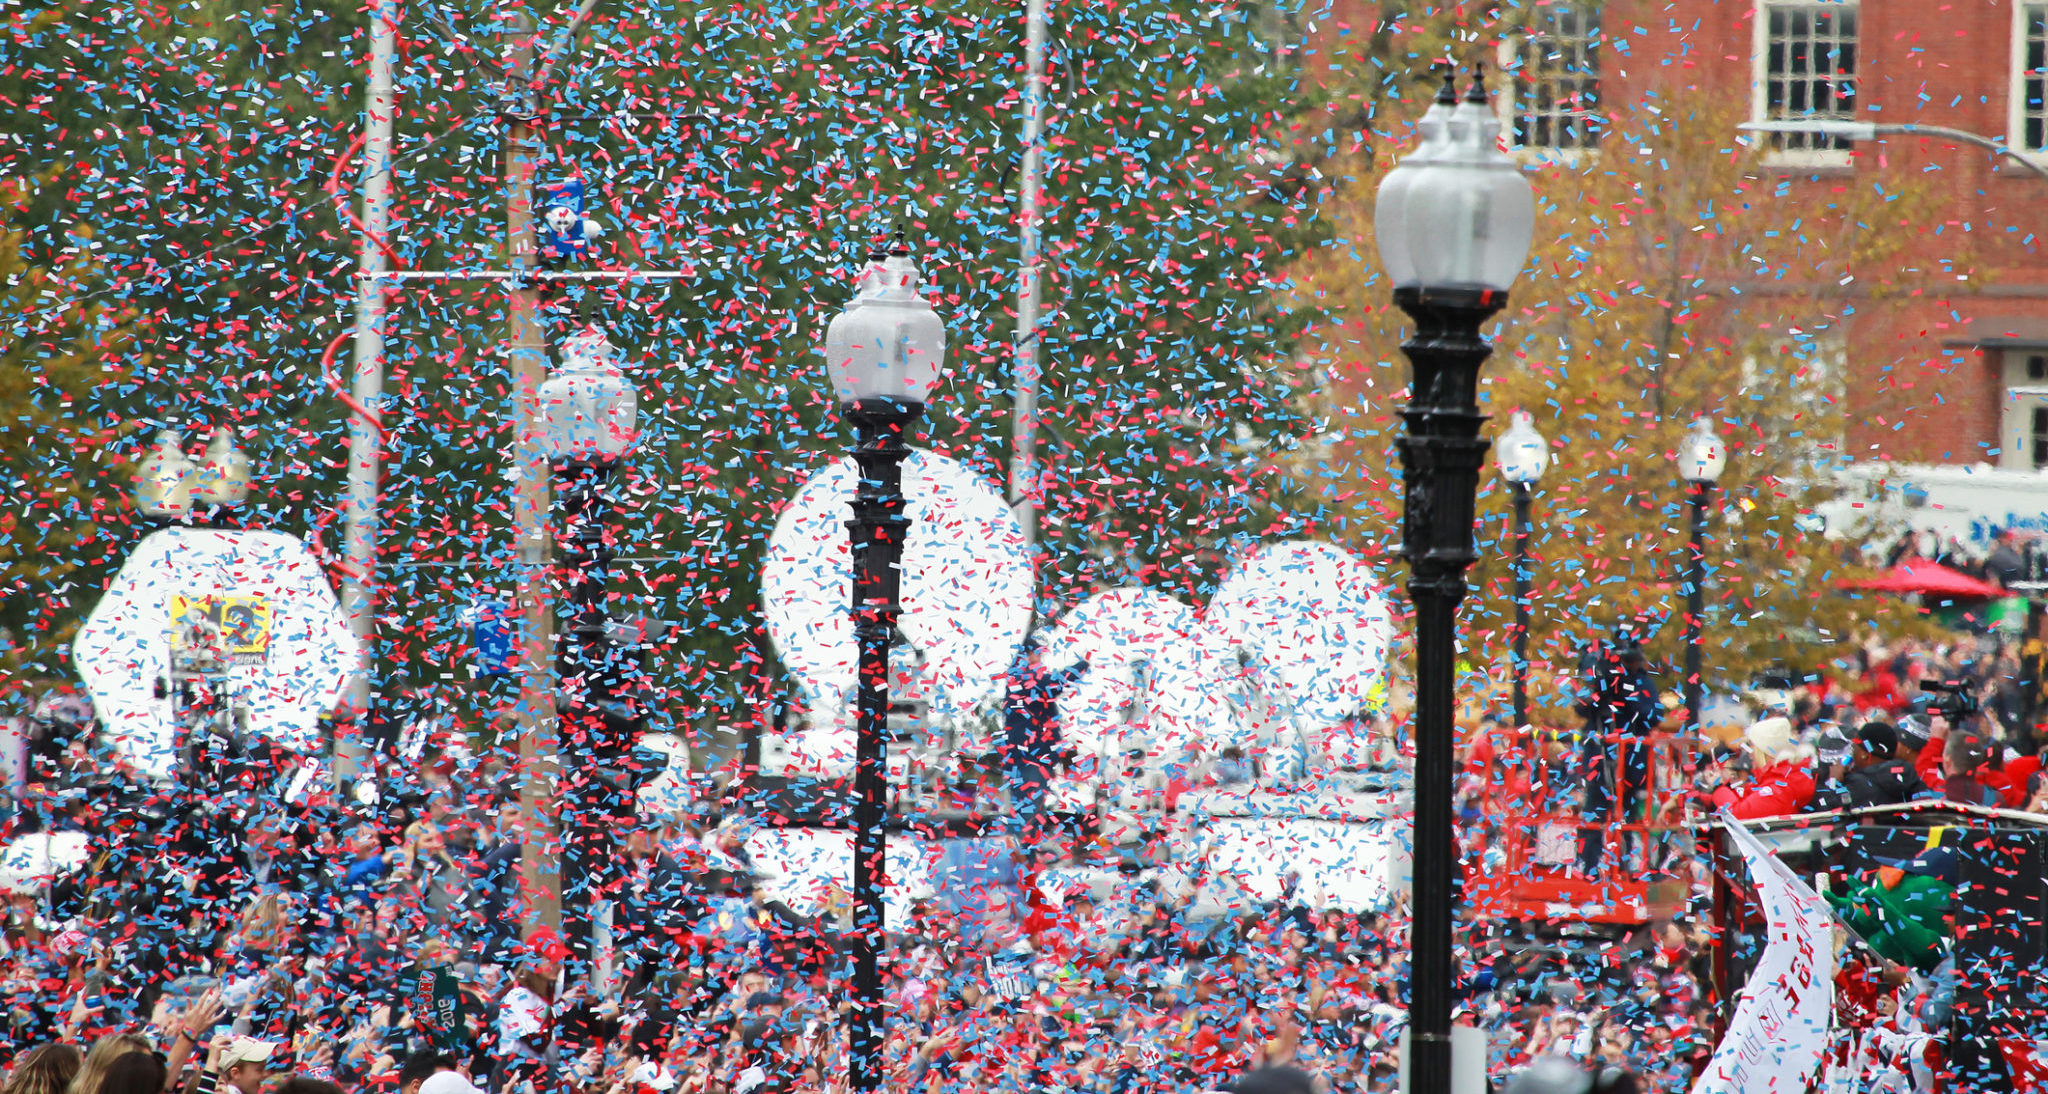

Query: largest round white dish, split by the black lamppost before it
left=762, top=449, right=1032, bottom=717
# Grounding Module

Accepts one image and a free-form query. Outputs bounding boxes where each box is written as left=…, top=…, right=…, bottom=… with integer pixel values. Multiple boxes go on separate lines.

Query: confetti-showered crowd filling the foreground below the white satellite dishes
left=0, top=688, right=1708, bottom=1094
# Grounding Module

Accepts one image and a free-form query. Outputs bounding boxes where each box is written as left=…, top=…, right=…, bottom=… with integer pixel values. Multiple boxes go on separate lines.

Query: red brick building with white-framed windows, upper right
left=1311, top=0, right=2048, bottom=524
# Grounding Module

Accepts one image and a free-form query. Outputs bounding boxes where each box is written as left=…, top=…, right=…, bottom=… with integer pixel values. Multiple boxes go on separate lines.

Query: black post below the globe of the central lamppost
left=844, top=399, right=924, bottom=1094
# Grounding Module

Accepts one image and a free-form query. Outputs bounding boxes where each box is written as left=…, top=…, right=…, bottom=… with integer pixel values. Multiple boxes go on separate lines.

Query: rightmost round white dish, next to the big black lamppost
left=1204, top=541, right=1395, bottom=731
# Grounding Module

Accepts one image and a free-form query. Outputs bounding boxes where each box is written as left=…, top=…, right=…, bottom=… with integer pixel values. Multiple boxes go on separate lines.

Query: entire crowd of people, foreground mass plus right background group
left=0, top=618, right=2048, bottom=1094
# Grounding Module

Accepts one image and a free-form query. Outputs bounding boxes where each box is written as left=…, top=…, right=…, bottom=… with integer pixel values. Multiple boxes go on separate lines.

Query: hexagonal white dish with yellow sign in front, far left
left=72, top=529, right=356, bottom=776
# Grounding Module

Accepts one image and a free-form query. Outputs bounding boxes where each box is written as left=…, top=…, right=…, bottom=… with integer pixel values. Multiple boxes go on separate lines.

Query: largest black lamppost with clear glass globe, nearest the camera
left=1374, top=74, right=1536, bottom=1092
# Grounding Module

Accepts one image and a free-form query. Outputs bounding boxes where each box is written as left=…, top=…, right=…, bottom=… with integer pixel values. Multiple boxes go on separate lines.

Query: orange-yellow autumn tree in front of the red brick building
left=1276, top=86, right=1968, bottom=717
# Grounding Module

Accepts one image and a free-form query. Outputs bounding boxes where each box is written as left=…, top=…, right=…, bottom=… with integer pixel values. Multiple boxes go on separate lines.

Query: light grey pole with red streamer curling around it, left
left=334, top=0, right=399, bottom=781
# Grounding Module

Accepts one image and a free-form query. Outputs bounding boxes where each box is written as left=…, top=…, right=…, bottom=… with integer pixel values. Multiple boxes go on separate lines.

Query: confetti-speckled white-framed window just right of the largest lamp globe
left=1499, top=0, right=1608, bottom=154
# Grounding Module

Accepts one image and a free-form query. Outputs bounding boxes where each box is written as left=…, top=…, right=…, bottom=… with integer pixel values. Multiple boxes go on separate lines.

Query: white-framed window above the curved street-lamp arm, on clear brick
left=1751, top=0, right=1862, bottom=166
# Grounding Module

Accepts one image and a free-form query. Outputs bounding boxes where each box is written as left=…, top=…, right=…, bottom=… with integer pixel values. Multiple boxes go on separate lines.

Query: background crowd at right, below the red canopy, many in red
left=1460, top=635, right=2048, bottom=832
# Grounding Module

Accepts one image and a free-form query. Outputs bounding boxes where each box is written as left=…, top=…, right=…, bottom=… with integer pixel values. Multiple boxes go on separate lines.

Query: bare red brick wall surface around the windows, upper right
left=1311, top=0, right=2048, bottom=463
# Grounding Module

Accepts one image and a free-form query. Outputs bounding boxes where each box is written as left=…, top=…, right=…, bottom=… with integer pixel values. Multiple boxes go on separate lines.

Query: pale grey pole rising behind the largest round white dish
left=1010, top=0, right=1044, bottom=549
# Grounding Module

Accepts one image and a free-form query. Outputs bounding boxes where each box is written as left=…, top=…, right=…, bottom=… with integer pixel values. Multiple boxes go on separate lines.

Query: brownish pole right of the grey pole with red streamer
left=504, top=8, right=561, bottom=928
